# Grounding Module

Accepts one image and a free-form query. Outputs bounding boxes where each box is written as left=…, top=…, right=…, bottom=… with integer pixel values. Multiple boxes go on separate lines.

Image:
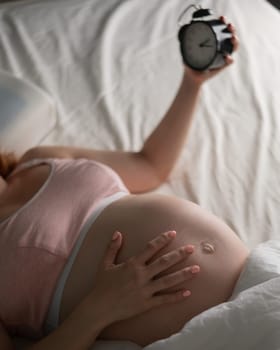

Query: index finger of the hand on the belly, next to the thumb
left=136, top=231, right=176, bottom=264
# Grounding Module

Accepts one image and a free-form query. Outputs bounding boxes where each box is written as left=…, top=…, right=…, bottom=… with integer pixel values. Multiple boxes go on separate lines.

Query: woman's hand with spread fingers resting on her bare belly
left=88, top=231, right=199, bottom=323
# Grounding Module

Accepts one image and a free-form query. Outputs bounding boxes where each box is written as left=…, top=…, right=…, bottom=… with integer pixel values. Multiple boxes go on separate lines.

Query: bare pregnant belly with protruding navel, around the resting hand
left=60, top=194, right=248, bottom=346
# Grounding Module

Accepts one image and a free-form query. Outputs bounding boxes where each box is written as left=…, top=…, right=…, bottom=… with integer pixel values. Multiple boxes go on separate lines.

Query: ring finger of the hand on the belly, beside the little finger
left=151, top=265, right=200, bottom=293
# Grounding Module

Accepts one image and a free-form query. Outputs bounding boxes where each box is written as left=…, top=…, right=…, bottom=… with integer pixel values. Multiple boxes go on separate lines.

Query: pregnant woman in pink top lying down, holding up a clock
left=0, top=17, right=248, bottom=350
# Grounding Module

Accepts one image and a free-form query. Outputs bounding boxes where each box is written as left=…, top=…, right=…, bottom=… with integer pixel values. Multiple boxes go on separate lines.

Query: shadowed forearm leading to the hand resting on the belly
left=28, top=297, right=110, bottom=350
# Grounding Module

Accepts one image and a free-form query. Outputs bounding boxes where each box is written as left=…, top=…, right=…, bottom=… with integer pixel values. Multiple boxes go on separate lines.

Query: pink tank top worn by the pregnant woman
left=0, top=159, right=129, bottom=338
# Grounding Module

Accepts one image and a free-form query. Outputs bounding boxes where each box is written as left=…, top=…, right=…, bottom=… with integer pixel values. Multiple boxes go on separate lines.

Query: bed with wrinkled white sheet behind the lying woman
left=0, top=0, right=280, bottom=350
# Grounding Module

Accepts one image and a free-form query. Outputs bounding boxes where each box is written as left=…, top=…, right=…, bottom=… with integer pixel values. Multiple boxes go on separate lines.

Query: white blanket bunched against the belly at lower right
left=144, top=241, right=280, bottom=350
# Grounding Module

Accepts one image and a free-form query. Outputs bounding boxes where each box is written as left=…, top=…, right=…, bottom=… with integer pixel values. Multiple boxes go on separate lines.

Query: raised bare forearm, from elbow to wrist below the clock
left=141, top=70, right=200, bottom=181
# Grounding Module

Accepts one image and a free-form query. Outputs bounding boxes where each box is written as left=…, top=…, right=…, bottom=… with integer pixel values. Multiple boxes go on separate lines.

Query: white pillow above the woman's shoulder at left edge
left=0, top=70, right=56, bottom=155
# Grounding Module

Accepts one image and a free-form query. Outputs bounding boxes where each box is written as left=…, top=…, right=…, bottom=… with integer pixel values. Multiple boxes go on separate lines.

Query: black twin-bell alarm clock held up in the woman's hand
left=178, top=5, right=233, bottom=71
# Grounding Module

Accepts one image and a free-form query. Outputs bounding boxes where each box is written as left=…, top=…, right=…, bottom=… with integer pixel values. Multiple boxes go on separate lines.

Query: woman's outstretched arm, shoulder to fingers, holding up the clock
left=21, top=17, right=238, bottom=193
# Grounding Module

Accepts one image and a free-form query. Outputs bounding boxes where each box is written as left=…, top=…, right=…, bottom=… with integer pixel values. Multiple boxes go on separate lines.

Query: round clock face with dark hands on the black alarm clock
left=181, top=21, right=217, bottom=70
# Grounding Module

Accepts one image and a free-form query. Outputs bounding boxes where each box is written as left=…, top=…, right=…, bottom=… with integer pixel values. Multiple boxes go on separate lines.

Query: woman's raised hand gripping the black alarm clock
left=185, top=16, right=239, bottom=85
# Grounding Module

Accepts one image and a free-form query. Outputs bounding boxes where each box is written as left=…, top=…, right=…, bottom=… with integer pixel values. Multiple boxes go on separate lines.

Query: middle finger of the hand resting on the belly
left=147, top=244, right=194, bottom=278
